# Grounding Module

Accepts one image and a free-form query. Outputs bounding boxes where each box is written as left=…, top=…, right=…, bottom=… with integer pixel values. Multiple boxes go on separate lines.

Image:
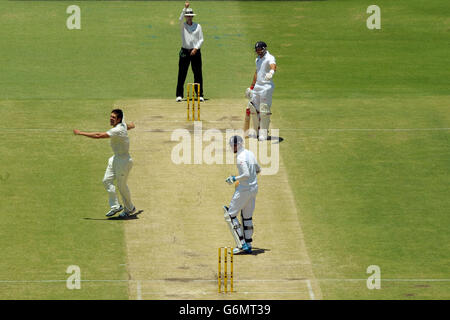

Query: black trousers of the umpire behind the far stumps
left=176, top=48, right=203, bottom=97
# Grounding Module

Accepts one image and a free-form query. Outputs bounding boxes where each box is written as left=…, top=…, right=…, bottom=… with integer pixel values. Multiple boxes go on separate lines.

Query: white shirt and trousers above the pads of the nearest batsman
left=228, top=148, right=261, bottom=219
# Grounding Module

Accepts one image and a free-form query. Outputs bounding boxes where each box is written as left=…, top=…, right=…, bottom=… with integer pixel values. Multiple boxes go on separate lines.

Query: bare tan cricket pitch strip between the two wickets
left=115, top=99, right=322, bottom=300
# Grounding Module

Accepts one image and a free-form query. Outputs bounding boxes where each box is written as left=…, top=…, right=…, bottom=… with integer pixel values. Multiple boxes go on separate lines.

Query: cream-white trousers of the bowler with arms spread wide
left=103, top=155, right=134, bottom=211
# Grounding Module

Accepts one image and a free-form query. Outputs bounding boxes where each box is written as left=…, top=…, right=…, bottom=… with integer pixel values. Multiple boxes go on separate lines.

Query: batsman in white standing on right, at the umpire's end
left=245, top=41, right=277, bottom=141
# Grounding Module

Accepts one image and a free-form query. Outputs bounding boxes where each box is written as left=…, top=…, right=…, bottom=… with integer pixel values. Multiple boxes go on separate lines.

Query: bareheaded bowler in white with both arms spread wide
left=73, top=109, right=136, bottom=218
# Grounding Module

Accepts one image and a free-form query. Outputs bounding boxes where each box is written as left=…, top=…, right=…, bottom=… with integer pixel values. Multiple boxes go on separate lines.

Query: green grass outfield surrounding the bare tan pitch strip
left=0, top=0, right=450, bottom=299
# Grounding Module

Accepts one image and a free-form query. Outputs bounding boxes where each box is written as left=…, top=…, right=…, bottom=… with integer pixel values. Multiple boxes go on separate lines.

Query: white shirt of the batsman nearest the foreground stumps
left=236, top=148, right=261, bottom=190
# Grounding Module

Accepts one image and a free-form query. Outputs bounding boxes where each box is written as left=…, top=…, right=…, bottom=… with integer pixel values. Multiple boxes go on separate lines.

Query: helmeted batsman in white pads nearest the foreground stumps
left=223, top=136, right=261, bottom=253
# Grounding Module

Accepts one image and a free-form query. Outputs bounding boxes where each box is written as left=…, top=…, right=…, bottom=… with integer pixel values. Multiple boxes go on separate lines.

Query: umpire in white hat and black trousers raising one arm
left=176, top=2, right=204, bottom=102
